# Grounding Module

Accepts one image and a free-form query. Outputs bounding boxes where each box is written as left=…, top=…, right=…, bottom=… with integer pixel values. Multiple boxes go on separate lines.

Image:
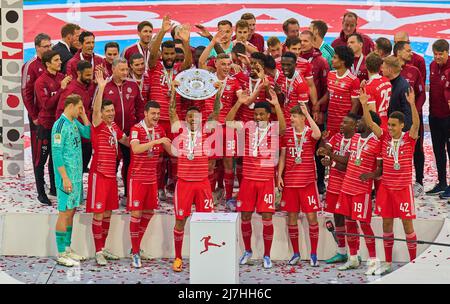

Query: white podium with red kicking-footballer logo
left=189, top=212, right=239, bottom=284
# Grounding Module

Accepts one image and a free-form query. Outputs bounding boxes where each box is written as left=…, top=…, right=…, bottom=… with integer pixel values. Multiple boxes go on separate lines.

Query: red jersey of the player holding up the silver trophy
left=172, top=128, right=211, bottom=181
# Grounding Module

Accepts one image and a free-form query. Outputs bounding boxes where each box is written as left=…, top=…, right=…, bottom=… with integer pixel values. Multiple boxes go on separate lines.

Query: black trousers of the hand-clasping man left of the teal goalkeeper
left=33, top=126, right=56, bottom=196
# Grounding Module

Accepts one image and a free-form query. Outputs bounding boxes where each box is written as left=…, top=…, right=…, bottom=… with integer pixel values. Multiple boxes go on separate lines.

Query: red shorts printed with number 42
left=376, top=183, right=416, bottom=220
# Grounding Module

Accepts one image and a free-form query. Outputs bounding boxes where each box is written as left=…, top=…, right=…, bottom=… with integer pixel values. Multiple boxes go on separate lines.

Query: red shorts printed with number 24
left=173, top=178, right=214, bottom=220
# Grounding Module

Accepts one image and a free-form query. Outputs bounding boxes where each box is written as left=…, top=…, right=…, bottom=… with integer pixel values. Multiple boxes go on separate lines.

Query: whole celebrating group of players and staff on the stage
left=22, top=12, right=450, bottom=275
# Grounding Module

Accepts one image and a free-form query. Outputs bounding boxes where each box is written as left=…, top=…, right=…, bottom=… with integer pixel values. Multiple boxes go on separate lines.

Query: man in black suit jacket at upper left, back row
left=53, top=23, right=81, bottom=74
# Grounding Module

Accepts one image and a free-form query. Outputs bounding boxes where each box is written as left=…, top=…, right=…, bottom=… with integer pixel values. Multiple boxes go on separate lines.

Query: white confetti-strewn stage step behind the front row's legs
left=0, top=133, right=449, bottom=262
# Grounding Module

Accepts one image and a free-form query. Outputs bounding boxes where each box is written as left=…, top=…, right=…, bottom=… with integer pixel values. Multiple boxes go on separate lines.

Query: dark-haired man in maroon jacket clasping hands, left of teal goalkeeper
left=33, top=51, right=72, bottom=206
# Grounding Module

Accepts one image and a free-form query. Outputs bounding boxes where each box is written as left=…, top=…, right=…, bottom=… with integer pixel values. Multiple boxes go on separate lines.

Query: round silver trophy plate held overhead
left=175, top=69, right=219, bottom=100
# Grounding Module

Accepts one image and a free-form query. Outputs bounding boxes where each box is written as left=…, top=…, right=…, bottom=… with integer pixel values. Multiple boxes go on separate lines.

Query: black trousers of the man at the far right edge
left=429, top=115, right=450, bottom=186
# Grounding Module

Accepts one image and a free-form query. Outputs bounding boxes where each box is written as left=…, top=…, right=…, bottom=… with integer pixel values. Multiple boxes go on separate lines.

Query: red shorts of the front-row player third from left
left=127, top=178, right=158, bottom=211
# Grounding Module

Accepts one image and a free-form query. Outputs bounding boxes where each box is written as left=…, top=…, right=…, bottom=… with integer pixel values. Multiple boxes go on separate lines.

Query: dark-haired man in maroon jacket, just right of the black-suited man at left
left=66, top=31, right=103, bottom=79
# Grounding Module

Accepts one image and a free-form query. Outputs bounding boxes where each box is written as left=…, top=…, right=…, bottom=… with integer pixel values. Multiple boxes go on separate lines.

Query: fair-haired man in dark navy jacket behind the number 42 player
left=381, top=56, right=412, bottom=131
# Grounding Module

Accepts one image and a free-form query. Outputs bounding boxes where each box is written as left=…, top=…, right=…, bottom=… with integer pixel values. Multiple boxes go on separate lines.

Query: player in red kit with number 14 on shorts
left=277, top=102, right=322, bottom=267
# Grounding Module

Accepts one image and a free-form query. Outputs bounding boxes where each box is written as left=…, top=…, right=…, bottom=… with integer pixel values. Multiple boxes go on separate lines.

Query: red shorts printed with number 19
left=336, top=192, right=372, bottom=223
